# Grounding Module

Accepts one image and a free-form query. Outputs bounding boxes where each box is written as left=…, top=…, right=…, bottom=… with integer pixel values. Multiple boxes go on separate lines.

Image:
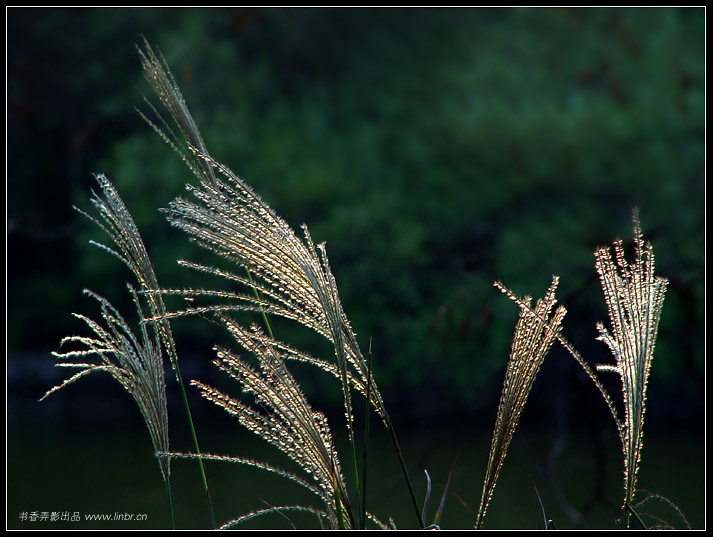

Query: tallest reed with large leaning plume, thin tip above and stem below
left=140, top=39, right=423, bottom=526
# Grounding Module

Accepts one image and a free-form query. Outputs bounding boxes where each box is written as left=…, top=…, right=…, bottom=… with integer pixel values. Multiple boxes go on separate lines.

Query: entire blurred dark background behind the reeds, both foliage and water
left=6, top=8, right=705, bottom=529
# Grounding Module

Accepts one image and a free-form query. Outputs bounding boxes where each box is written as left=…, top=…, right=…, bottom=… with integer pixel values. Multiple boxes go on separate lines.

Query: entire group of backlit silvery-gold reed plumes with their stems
left=45, top=43, right=666, bottom=529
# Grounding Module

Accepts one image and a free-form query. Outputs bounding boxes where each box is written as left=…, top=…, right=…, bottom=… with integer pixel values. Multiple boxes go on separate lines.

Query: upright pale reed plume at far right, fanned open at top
left=595, top=211, right=668, bottom=525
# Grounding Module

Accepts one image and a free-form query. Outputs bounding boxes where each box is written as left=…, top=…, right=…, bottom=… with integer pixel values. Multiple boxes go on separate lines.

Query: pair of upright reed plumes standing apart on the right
left=477, top=210, right=667, bottom=527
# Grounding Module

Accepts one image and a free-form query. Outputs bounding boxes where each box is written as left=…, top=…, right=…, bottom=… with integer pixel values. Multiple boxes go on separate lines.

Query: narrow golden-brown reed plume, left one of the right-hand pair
left=476, top=276, right=567, bottom=528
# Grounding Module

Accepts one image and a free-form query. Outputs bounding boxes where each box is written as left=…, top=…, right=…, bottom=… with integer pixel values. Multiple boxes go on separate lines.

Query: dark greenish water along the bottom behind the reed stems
left=7, top=401, right=705, bottom=530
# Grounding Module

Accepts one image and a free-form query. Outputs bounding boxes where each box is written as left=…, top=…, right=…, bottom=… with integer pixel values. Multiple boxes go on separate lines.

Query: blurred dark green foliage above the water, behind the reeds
left=7, top=8, right=705, bottom=440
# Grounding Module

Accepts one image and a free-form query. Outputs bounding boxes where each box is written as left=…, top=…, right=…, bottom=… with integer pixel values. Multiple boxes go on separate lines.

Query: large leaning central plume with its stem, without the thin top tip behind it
left=160, top=147, right=423, bottom=527
